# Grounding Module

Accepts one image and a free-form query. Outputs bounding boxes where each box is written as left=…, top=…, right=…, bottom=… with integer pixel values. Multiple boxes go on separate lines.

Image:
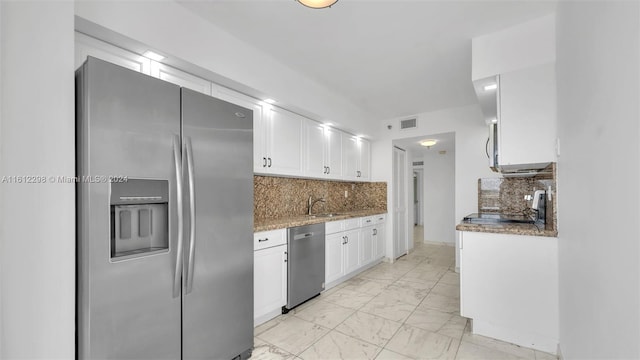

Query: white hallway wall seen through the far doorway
left=423, top=151, right=460, bottom=246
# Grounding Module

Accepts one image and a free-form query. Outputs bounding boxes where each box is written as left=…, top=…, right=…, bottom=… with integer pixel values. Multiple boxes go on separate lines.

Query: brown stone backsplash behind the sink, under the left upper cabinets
left=253, top=175, right=387, bottom=222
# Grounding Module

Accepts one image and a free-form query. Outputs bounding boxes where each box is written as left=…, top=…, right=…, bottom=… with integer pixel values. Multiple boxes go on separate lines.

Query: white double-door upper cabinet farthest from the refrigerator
left=342, top=135, right=371, bottom=181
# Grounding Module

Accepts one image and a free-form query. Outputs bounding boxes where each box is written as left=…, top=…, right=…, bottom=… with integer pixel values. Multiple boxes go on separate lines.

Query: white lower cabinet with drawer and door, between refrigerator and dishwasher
left=253, top=229, right=287, bottom=326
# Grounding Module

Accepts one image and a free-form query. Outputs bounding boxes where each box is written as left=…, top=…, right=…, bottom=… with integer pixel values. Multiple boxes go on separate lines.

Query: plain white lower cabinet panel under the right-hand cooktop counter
left=458, top=231, right=559, bottom=353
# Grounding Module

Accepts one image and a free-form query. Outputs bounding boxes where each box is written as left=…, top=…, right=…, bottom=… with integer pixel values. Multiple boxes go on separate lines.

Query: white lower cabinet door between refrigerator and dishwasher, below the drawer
left=253, top=245, right=287, bottom=324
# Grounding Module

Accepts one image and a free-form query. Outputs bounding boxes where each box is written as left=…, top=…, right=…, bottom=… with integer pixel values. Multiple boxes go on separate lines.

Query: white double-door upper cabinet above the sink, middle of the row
left=303, top=120, right=342, bottom=179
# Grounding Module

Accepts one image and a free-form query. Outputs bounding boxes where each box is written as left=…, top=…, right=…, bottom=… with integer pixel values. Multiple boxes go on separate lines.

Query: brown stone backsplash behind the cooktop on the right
left=478, top=163, right=557, bottom=230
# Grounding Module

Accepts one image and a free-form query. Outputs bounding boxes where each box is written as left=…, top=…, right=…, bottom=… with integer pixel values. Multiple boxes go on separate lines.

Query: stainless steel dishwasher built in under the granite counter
left=282, top=223, right=324, bottom=314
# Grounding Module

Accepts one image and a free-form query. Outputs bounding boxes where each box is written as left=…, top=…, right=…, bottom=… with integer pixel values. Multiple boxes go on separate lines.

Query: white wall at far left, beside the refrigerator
left=0, top=1, right=75, bottom=359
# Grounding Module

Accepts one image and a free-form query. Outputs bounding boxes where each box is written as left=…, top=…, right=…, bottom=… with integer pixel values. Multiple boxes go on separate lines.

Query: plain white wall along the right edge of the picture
left=557, top=2, right=640, bottom=359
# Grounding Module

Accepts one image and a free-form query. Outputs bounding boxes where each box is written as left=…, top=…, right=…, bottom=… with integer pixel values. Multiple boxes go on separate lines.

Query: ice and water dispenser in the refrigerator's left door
left=110, top=179, right=169, bottom=260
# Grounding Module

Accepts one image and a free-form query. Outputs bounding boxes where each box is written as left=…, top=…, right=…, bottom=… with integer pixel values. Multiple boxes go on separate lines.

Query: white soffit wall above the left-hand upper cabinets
left=75, top=1, right=368, bottom=132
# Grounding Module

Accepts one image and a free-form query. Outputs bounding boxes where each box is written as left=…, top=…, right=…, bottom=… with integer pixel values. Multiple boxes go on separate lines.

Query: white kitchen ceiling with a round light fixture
left=178, top=0, right=556, bottom=120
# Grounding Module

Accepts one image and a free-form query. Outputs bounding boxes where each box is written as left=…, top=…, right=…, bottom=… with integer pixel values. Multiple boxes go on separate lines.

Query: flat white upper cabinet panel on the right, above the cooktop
left=498, top=64, right=556, bottom=166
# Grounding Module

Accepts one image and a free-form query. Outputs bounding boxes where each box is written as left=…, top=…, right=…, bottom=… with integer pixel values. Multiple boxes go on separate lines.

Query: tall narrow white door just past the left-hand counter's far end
left=393, top=147, right=408, bottom=259
